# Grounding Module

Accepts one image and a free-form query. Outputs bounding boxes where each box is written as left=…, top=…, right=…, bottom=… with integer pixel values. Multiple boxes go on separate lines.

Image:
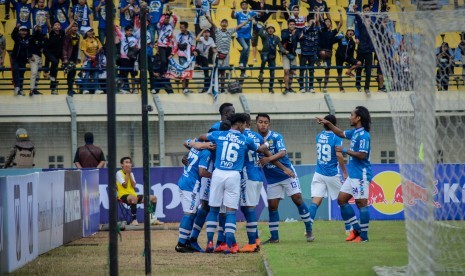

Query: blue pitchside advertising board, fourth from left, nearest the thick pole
left=81, top=170, right=100, bottom=237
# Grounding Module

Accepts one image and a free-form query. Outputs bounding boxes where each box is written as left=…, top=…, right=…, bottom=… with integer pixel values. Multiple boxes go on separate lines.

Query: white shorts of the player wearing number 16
left=208, top=169, right=241, bottom=209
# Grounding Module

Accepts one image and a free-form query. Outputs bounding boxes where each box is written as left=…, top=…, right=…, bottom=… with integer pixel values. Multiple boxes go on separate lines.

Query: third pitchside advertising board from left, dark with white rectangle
left=63, top=170, right=82, bottom=244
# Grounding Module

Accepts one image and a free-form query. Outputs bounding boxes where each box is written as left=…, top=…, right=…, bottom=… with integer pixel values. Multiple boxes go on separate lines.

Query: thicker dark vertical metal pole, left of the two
left=105, top=0, right=118, bottom=276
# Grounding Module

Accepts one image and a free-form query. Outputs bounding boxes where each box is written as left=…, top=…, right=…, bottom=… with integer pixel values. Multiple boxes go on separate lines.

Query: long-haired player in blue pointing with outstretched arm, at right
left=316, top=106, right=372, bottom=242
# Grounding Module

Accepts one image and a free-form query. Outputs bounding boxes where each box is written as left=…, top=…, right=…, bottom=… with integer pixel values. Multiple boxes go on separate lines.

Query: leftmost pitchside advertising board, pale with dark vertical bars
left=0, top=173, right=39, bottom=273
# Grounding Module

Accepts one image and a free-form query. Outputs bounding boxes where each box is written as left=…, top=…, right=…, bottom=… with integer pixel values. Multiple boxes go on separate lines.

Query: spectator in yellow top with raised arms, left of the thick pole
left=81, top=27, right=103, bottom=94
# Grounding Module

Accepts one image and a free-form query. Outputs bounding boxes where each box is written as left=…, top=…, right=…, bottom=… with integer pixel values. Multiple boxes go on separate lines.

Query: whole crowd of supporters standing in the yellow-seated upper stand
left=0, top=0, right=465, bottom=96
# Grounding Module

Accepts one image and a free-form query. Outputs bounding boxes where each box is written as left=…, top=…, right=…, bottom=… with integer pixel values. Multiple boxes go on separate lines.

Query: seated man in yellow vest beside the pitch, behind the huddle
left=116, top=157, right=163, bottom=226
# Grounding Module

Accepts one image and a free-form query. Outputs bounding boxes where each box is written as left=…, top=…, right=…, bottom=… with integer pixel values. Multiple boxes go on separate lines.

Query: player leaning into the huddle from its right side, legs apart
left=256, top=113, right=312, bottom=244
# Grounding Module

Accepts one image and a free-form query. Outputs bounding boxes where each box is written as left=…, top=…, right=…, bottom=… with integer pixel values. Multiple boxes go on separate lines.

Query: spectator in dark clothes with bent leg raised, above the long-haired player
left=336, top=28, right=362, bottom=93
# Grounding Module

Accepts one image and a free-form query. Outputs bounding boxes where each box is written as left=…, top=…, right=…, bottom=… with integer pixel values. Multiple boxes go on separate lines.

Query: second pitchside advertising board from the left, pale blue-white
left=37, top=171, right=65, bottom=254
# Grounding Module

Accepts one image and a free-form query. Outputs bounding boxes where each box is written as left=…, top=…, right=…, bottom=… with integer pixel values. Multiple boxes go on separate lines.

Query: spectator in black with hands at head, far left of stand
left=11, top=25, right=32, bottom=96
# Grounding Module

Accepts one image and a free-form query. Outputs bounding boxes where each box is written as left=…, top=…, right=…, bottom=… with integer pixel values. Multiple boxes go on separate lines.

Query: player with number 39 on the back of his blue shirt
left=309, top=115, right=347, bottom=241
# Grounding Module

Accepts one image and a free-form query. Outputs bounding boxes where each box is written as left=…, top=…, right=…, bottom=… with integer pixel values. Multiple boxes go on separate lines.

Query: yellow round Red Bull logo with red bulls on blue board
left=349, top=171, right=441, bottom=215
